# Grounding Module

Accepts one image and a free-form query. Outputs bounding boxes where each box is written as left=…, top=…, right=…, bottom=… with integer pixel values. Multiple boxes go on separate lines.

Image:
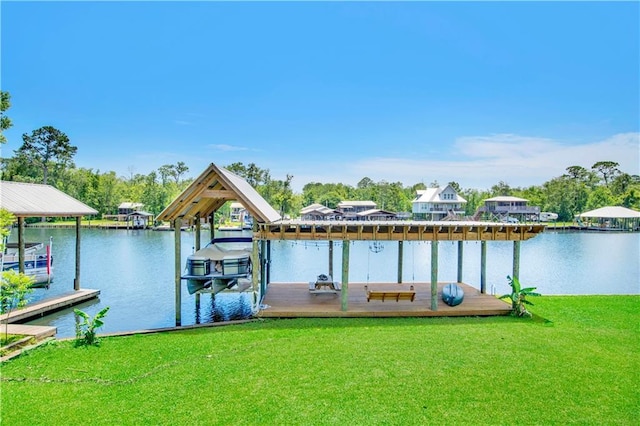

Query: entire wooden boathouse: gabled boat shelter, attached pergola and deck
left=158, top=164, right=545, bottom=325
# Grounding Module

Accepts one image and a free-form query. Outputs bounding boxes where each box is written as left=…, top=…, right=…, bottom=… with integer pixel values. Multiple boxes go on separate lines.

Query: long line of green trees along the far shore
left=0, top=92, right=640, bottom=221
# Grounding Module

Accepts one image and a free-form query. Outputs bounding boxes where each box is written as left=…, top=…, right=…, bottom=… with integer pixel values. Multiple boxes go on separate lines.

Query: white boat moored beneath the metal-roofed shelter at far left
left=0, top=238, right=53, bottom=288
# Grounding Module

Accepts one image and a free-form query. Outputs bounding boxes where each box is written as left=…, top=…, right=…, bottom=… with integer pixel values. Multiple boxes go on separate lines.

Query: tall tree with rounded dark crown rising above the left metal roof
left=16, top=126, right=78, bottom=185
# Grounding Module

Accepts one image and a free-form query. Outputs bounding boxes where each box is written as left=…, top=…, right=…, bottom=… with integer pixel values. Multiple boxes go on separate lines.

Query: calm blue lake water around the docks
left=12, top=228, right=640, bottom=337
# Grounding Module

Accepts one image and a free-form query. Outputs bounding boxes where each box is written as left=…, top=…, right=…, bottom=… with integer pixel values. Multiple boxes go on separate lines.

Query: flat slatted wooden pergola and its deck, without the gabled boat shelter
left=254, top=220, right=545, bottom=317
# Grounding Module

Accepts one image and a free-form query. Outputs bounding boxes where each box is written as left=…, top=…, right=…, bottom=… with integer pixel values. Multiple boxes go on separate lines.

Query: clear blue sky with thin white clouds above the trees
left=0, top=1, right=640, bottom=191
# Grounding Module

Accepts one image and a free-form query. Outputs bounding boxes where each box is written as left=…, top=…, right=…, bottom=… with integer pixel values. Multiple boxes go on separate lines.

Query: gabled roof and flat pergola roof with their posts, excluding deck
left=158, top=164, right=545, bottom=325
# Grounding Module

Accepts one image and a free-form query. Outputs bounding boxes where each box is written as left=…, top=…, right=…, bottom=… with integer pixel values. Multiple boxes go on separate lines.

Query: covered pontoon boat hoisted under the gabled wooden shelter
left=181, top=237, right=252, bottom=294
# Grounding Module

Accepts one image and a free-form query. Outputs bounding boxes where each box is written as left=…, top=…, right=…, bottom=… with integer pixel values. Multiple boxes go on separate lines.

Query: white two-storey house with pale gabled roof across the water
left=411, top=185, right=467, bottom=220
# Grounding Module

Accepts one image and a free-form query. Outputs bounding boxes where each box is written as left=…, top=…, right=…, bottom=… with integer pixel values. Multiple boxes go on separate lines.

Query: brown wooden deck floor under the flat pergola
left=258, top=282, right=511, bottom=318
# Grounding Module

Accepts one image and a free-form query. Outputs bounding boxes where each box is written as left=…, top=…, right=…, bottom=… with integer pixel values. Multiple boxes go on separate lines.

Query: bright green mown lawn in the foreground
left=1, top=296, right=640, bottom=425
